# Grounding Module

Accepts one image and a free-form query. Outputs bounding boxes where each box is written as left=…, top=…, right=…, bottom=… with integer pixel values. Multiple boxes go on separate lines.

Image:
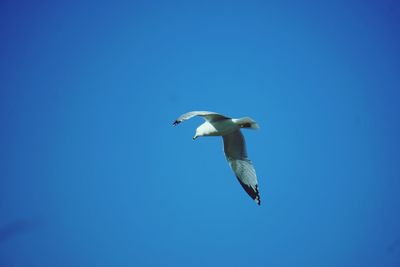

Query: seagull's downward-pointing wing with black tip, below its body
left=223, top=130, right=261, bottom=205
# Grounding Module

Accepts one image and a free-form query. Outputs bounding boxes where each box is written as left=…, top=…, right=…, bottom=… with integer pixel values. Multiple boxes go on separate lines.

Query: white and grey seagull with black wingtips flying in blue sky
left=173, top=111, right=261, bottom=205
